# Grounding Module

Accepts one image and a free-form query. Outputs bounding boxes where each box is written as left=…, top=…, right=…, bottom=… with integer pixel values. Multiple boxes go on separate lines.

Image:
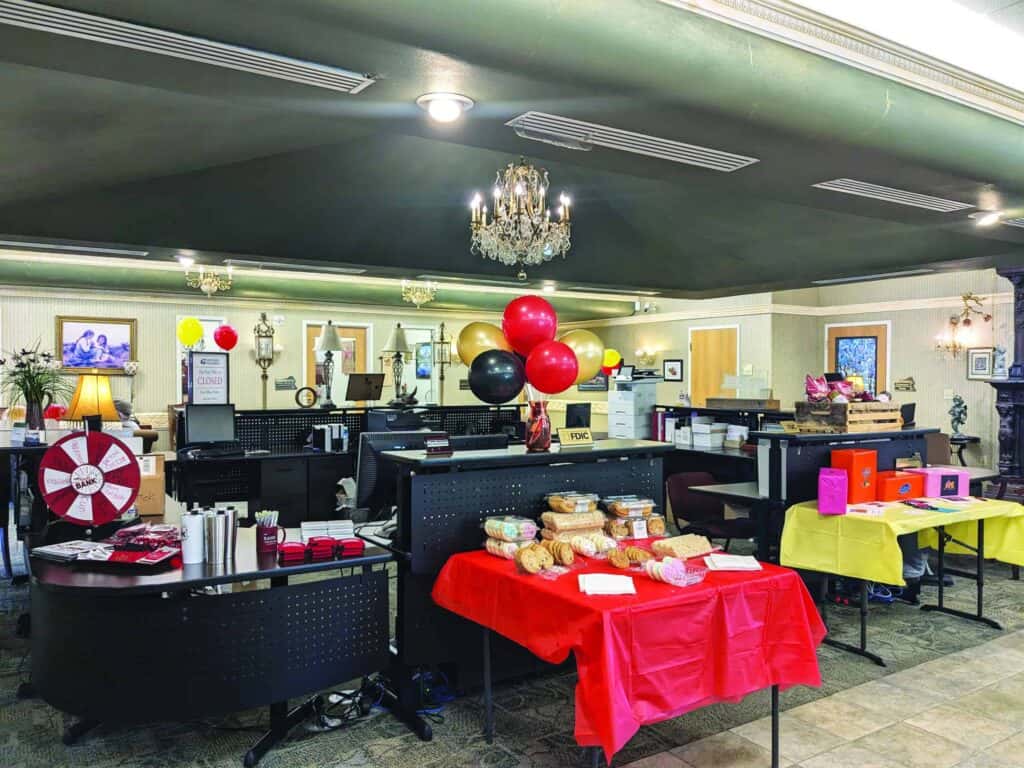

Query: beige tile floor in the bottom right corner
left=624, top=631, right=1024, bottom=768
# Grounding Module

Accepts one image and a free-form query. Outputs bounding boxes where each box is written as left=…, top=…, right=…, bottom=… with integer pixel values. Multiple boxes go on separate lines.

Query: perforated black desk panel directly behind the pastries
left=401, top=458, right=663, bottom=573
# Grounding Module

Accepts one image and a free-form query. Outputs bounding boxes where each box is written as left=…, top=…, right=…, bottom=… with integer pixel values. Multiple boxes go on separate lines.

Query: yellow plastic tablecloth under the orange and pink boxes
left=780, top=500, right=1022, bottom=585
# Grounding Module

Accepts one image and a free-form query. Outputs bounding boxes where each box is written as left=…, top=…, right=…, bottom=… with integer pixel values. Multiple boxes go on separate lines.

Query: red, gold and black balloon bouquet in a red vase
left=457, top=296, right=606, bottom=452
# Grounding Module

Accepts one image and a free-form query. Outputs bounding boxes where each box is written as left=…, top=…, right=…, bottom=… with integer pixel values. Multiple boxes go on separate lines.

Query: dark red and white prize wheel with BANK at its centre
left=39, top=432, right=140, bottom=526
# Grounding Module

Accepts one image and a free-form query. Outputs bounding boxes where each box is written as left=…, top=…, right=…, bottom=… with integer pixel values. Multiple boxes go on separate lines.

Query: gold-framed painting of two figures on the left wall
left=53, top=315, right=137, bottom=376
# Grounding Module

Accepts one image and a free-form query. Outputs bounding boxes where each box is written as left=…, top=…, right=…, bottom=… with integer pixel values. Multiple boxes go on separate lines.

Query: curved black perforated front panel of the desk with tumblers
left=32, top=566, right=388, bottom=722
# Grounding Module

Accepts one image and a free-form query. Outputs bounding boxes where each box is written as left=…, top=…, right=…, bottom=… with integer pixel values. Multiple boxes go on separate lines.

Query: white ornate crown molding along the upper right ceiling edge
left=658, top=0, right=1024, bottom=125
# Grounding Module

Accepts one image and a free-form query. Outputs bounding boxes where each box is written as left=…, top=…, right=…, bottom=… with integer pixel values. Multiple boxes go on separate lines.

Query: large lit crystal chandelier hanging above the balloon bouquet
left=470, top=158, right=571, bottom=280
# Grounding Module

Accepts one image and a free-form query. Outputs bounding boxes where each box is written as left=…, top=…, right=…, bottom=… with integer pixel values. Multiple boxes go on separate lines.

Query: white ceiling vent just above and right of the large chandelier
left=505, top=112, right=758, bottom=173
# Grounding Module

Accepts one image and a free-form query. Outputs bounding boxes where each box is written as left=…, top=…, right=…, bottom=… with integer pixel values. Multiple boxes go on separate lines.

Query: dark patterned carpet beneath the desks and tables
left=6, top=548, right=1024, bottom=768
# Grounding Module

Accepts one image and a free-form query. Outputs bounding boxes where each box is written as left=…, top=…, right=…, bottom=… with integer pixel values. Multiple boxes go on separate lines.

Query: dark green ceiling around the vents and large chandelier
left=0, top=0, right=1024, bottom=303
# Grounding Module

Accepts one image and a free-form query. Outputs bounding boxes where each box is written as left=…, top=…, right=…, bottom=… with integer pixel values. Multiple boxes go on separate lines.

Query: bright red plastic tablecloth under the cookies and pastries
left=433, top=551, right=825, bottom=762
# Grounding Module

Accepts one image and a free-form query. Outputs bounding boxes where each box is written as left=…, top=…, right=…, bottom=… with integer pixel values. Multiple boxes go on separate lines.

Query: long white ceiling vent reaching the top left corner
left=0, top=0, right=374, bottom=93
